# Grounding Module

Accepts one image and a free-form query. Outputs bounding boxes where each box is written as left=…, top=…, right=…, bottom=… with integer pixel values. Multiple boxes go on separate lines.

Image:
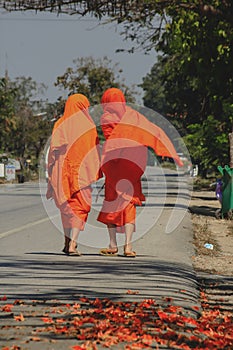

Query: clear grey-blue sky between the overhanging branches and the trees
left=0, top=9, right=156, bottom=103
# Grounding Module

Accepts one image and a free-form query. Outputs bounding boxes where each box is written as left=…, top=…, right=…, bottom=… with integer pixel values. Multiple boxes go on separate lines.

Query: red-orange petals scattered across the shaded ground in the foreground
left=1, top=291, right=233, bottom=350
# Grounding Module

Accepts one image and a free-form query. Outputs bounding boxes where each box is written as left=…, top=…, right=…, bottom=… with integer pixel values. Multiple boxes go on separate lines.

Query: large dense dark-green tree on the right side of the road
left=141, top=0, right=233, bottom=173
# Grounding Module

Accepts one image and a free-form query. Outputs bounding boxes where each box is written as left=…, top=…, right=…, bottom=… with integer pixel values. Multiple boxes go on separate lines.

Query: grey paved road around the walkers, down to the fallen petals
left=0, top=167, right=200, bottom=344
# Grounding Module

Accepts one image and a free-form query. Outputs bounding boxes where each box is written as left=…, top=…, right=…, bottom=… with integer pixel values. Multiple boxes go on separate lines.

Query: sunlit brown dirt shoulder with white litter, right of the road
left=189, top=191, right=233, bottom=276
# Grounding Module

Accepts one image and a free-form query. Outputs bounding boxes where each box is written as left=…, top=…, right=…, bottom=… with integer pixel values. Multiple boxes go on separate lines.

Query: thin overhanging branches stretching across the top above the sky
left=0, top=0, right=233, bottom=50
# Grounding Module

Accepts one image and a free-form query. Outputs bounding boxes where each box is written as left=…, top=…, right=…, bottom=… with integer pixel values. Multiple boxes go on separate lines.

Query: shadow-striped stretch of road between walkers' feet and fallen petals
left=0, top=252, right=198, bottom=318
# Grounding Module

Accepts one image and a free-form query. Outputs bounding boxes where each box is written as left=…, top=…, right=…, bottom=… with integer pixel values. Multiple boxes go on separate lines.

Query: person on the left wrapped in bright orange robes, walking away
left=46, top=94, right=101, bottom=255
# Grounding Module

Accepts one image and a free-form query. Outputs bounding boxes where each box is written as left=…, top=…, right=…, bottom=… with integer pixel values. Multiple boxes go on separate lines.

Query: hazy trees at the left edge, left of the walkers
left=0, top=77, right=54, bottom=168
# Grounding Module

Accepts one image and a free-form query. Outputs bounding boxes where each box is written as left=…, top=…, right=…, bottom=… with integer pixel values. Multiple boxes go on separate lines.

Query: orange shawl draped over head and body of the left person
left=47, top=94, right=101, bottom=205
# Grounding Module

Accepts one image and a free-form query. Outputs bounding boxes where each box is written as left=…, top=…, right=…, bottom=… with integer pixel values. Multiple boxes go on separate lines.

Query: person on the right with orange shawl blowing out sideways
left=97, top=88, right=183, bottom=257
